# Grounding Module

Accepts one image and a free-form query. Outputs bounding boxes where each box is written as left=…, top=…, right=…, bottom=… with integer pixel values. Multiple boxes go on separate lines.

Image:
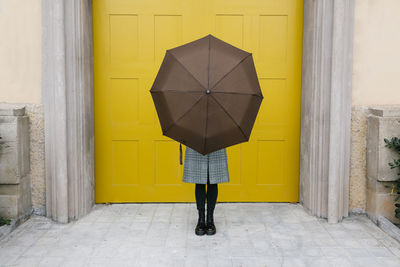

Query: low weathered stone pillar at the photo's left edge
left=0, top=104, right=32, bottom=220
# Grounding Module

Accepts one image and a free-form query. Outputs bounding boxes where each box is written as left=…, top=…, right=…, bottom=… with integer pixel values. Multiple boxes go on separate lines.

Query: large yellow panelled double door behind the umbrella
left=93, top=0, right=303, bottom=203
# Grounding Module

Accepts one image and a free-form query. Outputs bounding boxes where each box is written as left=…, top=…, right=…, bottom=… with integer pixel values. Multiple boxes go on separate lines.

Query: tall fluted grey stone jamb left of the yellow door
left=42, top=0, right=94, bottom=223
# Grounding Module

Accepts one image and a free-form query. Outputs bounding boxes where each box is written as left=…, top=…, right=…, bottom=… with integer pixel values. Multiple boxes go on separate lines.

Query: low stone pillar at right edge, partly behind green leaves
left=367, top=106, right=400, bottom=223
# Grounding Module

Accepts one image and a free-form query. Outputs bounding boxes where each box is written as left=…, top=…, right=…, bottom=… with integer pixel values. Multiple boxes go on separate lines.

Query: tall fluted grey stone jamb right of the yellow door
left=300, top=0, right=354, bottom=223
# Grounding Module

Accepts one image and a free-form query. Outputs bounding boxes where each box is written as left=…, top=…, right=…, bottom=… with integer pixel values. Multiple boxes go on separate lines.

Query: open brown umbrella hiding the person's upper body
left=150, top=34, right=264, bottom=163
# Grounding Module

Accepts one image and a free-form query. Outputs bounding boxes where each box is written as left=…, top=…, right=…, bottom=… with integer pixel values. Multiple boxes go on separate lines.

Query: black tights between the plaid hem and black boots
left=195, top=170, right=218, bottom=211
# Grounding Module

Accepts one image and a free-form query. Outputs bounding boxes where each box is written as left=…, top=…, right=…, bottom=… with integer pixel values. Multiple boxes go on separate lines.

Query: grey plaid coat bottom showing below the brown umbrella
left=182, top=146, right=229, bottom=184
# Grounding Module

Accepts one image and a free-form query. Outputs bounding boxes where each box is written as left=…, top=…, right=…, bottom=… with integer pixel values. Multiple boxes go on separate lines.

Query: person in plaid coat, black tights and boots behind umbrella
left=182, top=146, right=229, bottom=235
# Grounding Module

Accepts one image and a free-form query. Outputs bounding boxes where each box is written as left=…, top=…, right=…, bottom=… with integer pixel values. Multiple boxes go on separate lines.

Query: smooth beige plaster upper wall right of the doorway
left=353, top=0, right=400, bottom=106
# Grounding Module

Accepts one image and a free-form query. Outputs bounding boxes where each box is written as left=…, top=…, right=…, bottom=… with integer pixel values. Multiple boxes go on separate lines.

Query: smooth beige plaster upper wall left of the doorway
left=0, top=0, right=42, bottom=103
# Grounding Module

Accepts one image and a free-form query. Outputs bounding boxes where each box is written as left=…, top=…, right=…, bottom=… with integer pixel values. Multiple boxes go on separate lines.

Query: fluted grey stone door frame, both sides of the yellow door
left=42, top=0, right=354, bottom=223
